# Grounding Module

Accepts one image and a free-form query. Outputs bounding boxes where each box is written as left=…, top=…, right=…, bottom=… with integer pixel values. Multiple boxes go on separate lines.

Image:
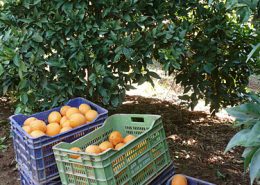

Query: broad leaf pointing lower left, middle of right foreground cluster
left=224, top=129, right=251, bottom=153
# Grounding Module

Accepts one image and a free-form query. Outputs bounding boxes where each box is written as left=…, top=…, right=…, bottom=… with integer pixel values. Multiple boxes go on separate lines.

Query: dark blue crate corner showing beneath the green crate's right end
left=150, top=164, right=174, bottom=185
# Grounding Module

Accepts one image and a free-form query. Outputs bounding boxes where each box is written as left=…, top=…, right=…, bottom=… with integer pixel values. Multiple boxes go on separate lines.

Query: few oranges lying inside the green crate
left=70, top=131, right=135, bottom=159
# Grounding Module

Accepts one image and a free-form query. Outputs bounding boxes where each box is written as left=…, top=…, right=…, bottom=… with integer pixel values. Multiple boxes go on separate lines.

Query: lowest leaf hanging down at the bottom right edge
left=250, top=148, right=260, bottom=185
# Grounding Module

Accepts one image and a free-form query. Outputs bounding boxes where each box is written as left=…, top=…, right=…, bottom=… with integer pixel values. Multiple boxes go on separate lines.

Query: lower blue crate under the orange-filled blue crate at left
left=18, top=166, right=61, bottom=185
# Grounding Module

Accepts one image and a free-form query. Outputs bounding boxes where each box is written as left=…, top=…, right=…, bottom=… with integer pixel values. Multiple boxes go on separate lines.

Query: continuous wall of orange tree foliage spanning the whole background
left=0, top=0, right=257, bottom=113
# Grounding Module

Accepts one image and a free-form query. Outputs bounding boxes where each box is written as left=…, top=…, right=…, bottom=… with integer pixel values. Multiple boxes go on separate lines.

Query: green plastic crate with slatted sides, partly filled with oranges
left=53, top=114, right=171, bottom=185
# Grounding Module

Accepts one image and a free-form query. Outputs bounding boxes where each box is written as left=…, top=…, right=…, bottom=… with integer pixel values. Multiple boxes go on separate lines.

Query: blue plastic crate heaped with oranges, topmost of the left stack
left=10, top=98, right=108, bottom=182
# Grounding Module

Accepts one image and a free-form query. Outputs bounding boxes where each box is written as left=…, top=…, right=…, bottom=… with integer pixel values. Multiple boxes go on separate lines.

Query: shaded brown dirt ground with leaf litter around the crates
left=0, top=96, right=249, bottom=185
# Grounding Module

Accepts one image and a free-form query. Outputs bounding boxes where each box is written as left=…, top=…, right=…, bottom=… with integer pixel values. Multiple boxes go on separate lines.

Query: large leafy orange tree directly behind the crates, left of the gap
left=0, top=0, right=187, bottom=112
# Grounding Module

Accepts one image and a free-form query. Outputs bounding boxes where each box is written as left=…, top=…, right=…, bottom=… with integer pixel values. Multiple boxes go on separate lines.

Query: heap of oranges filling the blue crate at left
left=23, top=104, right=98, bottom=138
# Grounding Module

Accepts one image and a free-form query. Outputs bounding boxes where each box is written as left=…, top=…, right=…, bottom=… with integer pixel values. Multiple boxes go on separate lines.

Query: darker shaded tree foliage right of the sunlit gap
left=173, top=1, right=257, bottom=114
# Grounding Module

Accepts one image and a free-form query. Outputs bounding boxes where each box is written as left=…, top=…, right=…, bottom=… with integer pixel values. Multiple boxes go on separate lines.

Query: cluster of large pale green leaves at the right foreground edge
left=225, top=97, right=260, bottom=184
